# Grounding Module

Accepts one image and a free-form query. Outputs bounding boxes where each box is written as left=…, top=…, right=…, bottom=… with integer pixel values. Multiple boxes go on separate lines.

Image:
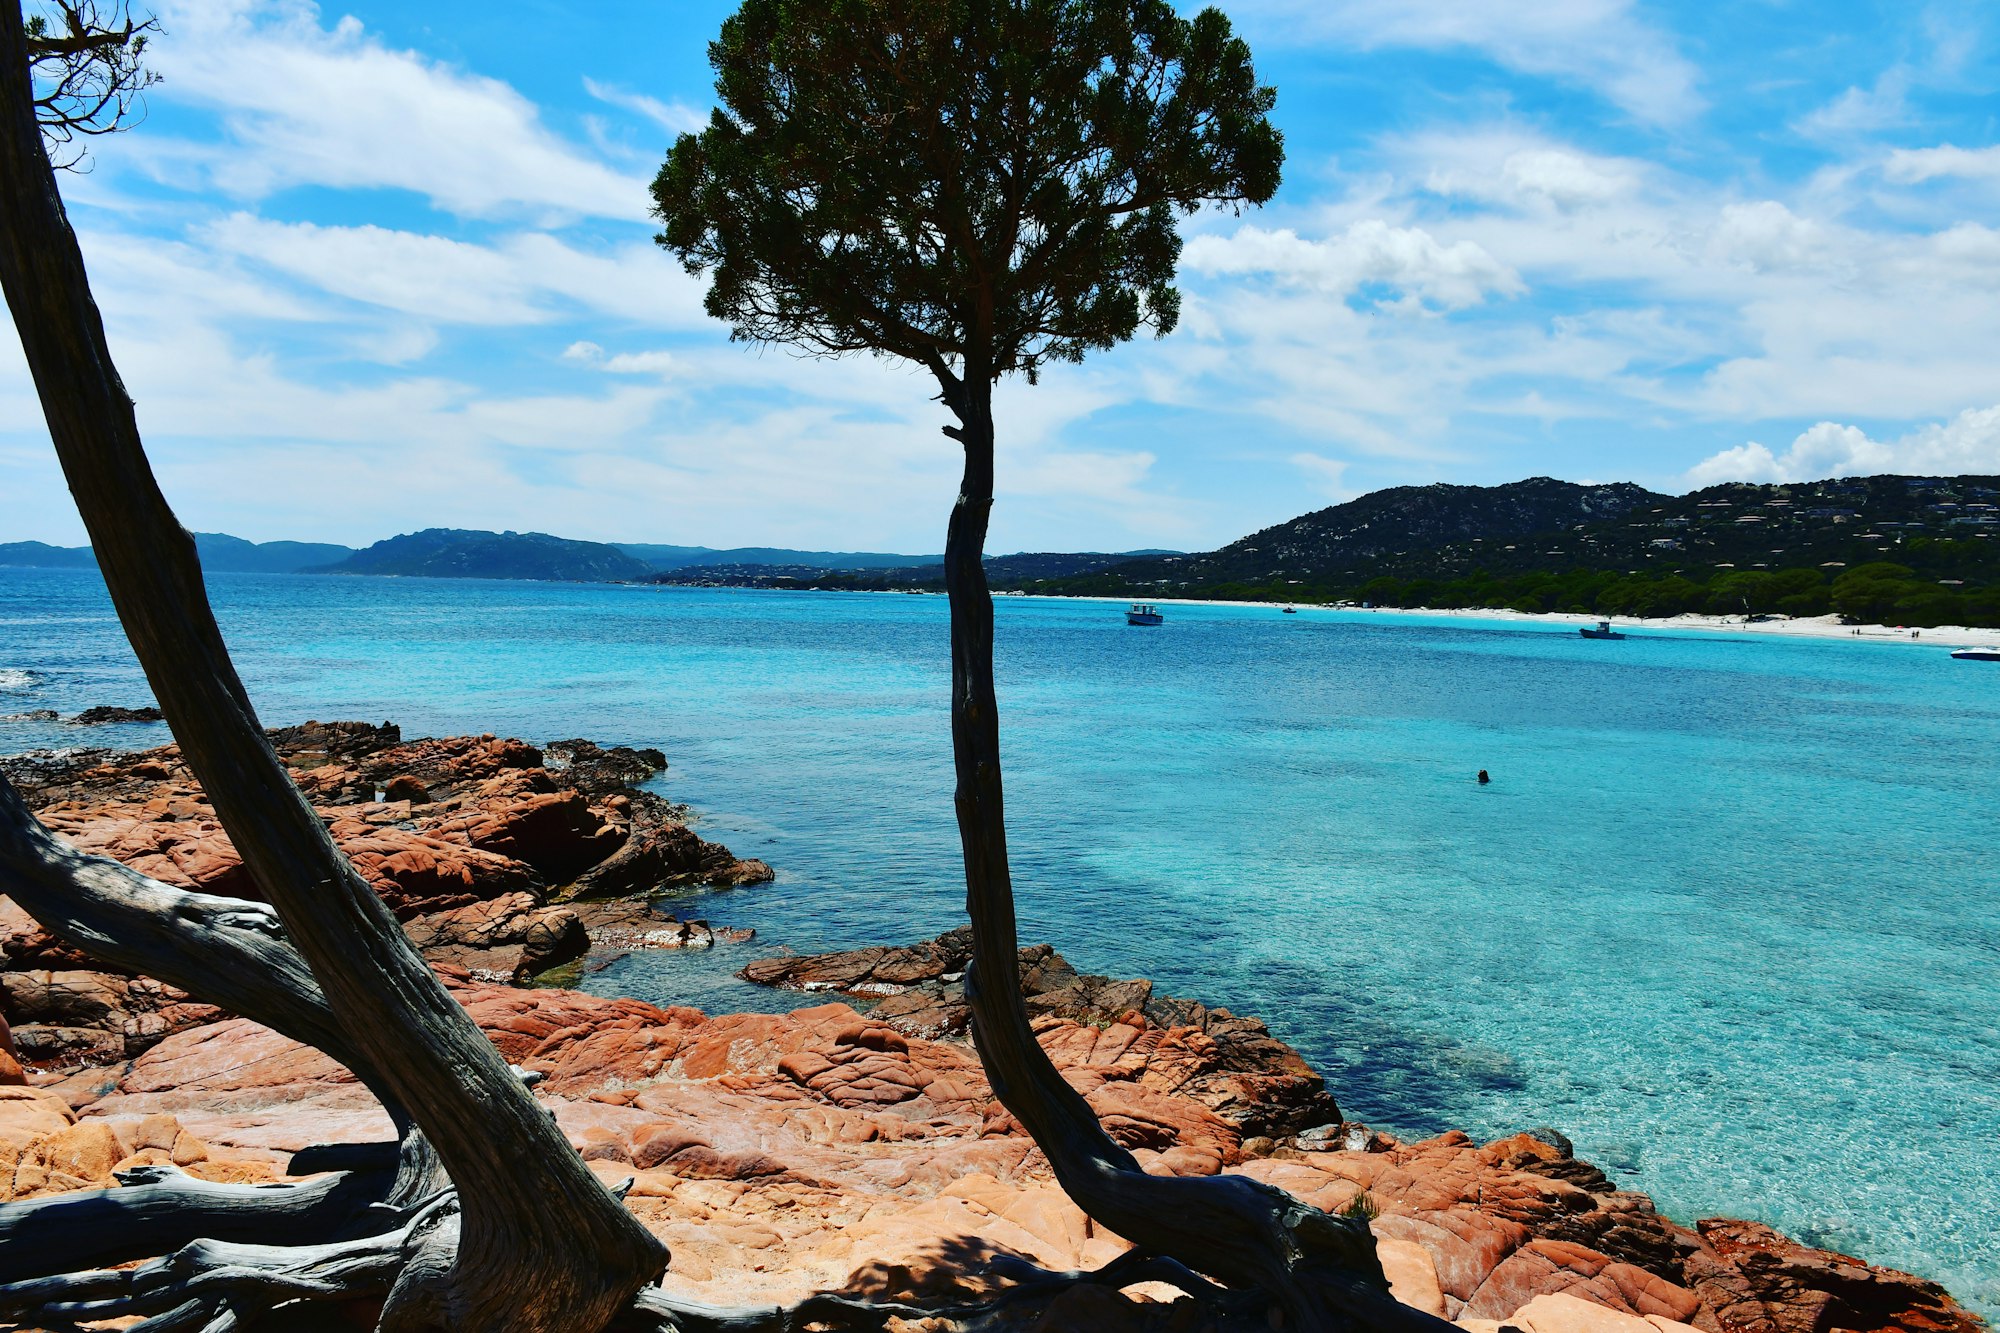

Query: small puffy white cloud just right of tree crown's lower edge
left=1182, top=218, right=1524, bottom=310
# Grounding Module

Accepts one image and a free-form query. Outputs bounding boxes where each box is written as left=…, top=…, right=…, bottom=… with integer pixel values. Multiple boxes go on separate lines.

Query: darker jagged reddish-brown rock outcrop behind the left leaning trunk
left=0, top=723, right=772, bottom=1067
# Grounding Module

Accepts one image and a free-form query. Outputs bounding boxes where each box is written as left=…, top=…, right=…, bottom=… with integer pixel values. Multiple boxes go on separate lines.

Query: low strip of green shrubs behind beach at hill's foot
left=1048, top=556, right=2000, bottom=626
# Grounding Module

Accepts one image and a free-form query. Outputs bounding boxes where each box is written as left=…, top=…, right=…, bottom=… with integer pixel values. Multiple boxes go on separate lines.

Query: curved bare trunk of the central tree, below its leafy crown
left=940, top=374, right=1452, bottom=1331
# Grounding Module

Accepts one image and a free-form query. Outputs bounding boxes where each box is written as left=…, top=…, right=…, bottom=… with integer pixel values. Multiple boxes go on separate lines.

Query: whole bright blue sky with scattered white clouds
left=11, top=0, right=2000, bottom=550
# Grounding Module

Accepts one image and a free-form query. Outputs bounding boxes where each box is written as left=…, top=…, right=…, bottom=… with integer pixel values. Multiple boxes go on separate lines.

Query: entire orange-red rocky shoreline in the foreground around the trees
left=0, top=723, right=1982, bottom=1333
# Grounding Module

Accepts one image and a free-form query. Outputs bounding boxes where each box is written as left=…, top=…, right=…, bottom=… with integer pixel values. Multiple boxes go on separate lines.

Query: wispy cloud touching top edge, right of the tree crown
left=1230, top=0, right=1702, bottom=124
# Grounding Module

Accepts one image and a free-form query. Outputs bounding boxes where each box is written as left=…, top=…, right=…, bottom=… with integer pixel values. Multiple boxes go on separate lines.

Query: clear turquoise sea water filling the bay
left=11, top=568, right=2000, bottom=1313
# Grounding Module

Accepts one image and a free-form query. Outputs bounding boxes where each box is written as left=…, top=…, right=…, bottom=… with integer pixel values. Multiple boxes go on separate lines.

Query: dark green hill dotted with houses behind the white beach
left=1048, top=474, right=2000, bottom=624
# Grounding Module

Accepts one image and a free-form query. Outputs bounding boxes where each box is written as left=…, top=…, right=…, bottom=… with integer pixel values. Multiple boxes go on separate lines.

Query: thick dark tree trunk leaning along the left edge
left=0, top=0, right=666, bottom=1333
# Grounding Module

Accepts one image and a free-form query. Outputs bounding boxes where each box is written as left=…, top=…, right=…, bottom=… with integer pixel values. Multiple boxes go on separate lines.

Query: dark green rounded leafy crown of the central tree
left=652, top=0, right=1284, bottom=384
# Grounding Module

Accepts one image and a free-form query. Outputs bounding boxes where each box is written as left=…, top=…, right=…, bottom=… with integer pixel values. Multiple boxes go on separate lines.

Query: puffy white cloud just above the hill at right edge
left=1688, top=406, right=2000, bottom=486
